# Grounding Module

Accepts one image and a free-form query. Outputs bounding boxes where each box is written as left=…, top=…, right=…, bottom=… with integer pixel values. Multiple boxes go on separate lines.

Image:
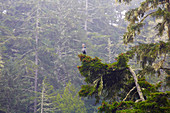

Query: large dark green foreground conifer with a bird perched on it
left=78, top=0, right=170, bottom=113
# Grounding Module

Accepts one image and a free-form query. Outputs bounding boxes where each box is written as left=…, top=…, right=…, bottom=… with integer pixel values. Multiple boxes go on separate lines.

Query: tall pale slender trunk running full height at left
left=34, top=1, right=39, bottom=113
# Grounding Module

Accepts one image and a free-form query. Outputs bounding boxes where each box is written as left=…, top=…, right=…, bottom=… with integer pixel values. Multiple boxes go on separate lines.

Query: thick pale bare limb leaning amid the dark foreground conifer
left=129, top=67, right=145, bottom=101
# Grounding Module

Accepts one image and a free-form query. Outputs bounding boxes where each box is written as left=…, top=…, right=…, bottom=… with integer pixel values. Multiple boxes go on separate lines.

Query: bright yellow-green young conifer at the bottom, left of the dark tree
left=54, top=83, right=86, bottom=113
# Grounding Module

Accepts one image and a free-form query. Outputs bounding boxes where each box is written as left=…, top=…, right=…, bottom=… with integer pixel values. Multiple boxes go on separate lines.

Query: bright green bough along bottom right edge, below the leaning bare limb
left=98, top=92, right=170, bottom=113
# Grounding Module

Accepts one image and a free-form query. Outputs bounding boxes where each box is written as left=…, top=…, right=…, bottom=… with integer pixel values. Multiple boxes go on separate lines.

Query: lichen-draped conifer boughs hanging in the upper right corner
left=121, top=0, right=170, bottom=89
